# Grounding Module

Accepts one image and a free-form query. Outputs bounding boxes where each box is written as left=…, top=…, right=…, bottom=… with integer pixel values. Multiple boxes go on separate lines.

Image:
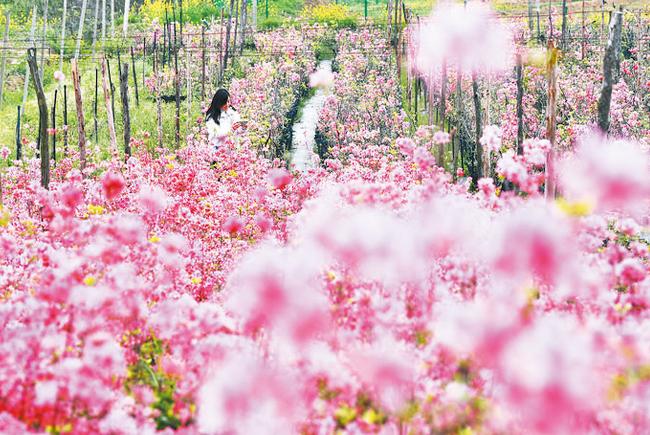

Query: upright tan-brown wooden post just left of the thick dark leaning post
left=544, top=40, right=558, bottom=201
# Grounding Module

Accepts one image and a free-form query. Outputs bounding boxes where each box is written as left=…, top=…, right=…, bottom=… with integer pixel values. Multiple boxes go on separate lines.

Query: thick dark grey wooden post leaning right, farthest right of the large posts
left=598, top=11, right=623, bottom=133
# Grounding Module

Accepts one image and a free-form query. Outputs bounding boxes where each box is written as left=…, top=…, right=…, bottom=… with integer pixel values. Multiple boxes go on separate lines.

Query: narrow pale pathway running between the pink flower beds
left=291, top=60, right=332, bottom=171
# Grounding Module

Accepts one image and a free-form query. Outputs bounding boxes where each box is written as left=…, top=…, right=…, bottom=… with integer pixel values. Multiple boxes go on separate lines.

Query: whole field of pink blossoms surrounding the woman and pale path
left=0, top=0, right=650, bottom=435
